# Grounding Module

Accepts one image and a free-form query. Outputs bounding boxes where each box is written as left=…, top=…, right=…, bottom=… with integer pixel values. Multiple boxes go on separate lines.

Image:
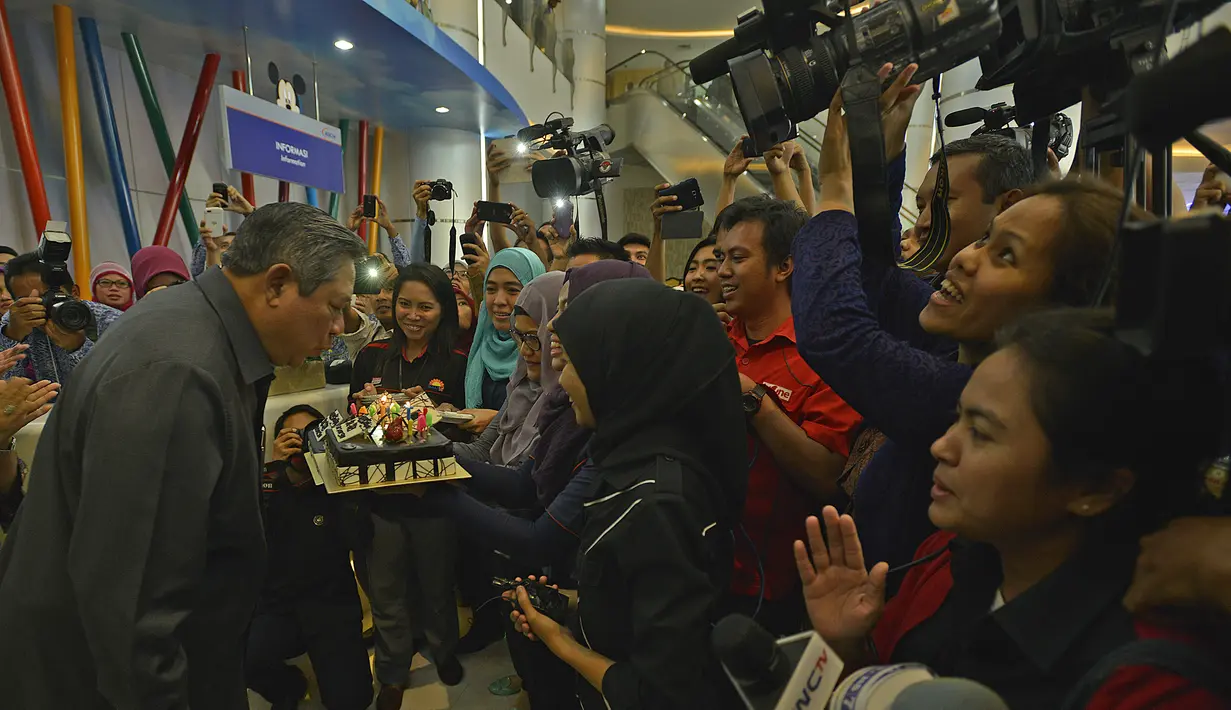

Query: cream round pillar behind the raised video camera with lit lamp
left=555, top=0, right=608, bottom=240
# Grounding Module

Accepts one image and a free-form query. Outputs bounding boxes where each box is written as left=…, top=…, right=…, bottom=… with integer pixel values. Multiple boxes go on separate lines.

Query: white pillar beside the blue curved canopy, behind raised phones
left=406, top=128, right=483, bottom=266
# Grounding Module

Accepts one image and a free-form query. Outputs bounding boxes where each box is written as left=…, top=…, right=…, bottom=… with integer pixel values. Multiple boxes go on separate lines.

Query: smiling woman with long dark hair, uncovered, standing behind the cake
left=351, top=263, right=467, bottom=708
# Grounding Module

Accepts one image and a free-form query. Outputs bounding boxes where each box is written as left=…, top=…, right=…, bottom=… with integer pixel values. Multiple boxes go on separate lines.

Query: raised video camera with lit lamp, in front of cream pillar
left=517, top=116, right=624, bottom=239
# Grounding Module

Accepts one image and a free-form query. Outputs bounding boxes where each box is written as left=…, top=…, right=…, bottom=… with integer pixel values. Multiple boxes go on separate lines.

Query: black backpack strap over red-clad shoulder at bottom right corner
left=1061, top=639, right=1231, bottom=710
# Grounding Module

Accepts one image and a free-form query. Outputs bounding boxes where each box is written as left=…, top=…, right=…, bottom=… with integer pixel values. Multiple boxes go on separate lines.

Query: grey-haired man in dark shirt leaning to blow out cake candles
left=0, top=203, right=364, bottom=710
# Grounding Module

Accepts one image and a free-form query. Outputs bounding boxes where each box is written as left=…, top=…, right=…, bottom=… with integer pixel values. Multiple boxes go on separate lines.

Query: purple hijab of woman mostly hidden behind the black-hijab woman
left=531, top=260, right=654, bottom=508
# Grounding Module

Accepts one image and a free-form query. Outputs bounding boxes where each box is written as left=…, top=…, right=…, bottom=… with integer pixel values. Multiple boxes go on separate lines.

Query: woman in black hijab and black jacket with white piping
left=513, top=281, right=747, bottom=710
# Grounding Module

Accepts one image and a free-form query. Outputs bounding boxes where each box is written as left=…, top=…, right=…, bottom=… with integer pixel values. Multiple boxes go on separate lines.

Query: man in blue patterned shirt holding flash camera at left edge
left=0, top=252, right=122, bottom=385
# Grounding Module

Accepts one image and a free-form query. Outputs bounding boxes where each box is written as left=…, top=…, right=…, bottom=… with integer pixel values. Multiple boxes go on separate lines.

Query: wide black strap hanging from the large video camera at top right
left=841, top=60, right=896, bottom=263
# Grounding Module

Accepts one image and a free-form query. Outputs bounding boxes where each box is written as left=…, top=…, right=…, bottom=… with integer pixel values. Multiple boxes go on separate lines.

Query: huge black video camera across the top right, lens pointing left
left=689, top=0, right=1222, bottom=150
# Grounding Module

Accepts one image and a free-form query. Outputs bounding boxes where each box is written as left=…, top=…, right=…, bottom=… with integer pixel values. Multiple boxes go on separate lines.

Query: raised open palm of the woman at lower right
left=795, top=506, right=889, bottom=644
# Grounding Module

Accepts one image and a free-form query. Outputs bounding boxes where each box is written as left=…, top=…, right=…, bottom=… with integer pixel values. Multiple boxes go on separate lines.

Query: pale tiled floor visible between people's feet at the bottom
left=247, top=641, right=517, bottom=710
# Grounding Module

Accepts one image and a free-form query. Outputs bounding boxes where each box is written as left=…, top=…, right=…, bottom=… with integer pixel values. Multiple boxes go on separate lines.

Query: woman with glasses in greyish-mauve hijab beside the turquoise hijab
left=453, top=272, right=564, bottom=470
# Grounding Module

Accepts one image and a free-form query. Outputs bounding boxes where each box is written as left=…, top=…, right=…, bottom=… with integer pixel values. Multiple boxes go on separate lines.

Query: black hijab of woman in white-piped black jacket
left=555, top=279, right=748, bottom=525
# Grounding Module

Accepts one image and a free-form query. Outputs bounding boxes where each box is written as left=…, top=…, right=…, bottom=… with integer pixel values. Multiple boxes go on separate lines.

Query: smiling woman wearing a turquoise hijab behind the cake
left=463, top=247, right=544, bottom=433
